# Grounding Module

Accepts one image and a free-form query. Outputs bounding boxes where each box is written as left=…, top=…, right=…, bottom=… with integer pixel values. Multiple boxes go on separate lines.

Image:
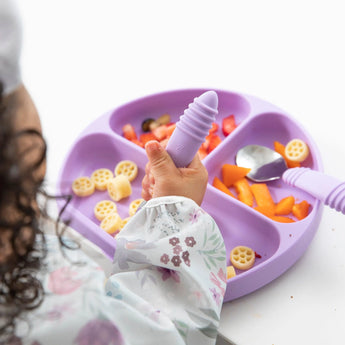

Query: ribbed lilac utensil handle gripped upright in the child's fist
left=167, top=91, right=218, bottom=168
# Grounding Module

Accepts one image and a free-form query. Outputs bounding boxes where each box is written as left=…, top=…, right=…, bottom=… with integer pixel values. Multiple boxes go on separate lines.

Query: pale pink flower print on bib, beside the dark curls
left=48, top=266, right=82, bottom=295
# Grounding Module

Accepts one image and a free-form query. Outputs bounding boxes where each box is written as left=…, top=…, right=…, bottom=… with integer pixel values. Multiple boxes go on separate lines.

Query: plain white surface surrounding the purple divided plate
left=18, top=0, right=345, bottom=345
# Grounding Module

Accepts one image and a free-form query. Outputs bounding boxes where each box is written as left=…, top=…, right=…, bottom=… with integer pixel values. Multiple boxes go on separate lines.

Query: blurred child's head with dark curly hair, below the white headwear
left=0, top=84, right=46, bottom=343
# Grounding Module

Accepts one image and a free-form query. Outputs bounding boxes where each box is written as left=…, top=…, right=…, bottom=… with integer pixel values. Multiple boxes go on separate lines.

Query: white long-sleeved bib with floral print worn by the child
left=18, top=197, right=226, bottom=345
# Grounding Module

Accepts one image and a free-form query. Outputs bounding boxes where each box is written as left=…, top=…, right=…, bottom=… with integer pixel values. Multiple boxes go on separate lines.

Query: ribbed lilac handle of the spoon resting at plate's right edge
left=282, top=168, right=345, bottom=214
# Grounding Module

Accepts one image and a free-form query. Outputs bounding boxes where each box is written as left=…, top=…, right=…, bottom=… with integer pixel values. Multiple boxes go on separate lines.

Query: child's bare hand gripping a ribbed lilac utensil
left=142, top=141, right=208, bottom=205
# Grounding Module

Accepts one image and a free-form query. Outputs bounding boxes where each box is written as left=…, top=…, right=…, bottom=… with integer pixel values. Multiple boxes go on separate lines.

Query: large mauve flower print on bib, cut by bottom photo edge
left=74, top=319, right=124, bottom=345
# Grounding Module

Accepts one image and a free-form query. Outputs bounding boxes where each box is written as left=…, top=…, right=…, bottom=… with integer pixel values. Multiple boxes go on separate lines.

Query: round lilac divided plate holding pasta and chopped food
left=57, top=89, right=322, bottom=302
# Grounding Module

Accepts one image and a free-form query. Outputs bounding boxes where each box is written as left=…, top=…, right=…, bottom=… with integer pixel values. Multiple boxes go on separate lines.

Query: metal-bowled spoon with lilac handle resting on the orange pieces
left=236, top=145, right=345, bottom=214
